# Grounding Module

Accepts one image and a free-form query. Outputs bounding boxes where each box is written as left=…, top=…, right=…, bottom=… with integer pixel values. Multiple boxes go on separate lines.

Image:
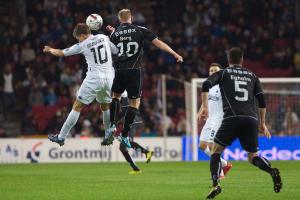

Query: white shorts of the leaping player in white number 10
left=77, top=75, right=114, bottom=105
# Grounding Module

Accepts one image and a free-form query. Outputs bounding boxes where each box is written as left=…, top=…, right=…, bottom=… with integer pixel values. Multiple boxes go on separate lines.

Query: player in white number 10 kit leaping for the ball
left=43, top=23, right=118, bottom=146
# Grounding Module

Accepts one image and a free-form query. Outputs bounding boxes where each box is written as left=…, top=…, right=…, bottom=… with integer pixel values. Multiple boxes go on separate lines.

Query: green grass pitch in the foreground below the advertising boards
left=0, top=161, right=300, bottom=200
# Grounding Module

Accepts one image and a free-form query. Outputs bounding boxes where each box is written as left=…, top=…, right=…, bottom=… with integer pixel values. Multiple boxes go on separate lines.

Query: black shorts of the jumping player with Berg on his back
left=112, top=69, right=143, bottom=99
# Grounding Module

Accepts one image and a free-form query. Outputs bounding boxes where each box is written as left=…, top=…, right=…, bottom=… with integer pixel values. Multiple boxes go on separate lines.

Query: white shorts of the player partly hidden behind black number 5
left=200, top=119, right=223, bottom=143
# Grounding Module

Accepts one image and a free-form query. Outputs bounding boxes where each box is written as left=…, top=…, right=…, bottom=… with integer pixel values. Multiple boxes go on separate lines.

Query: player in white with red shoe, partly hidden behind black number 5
left=198, top=63, right=232, bottom=178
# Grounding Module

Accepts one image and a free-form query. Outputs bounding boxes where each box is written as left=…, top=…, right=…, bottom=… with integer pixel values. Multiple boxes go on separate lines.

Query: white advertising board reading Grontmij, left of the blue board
left=0, top=137, right=182, bottom=163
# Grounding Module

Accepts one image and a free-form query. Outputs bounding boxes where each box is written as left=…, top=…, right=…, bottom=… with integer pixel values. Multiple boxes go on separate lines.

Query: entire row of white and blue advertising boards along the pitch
left=0, top=136, right=300, bottom=163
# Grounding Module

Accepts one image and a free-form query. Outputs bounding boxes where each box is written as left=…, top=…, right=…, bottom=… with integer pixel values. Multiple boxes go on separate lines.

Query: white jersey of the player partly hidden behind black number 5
left=207, top=85, right=224, bottom=120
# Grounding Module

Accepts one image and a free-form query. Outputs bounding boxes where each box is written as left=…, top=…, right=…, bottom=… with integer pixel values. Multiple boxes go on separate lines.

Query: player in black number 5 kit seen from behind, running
left=198, top=47, right=282, bottom=199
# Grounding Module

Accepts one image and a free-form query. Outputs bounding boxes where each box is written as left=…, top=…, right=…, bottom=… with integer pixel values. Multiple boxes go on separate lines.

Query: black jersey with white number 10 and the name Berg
left=110, top=23, right=157, bottom=69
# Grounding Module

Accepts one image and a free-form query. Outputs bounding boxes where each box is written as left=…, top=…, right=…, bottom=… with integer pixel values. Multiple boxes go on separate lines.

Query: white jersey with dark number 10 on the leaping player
left=63, top=34, right=118, bottom=77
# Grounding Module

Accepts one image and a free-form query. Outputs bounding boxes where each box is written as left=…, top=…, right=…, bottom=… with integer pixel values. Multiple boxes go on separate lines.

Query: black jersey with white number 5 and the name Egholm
left=202, top=66, right=263, bottom=119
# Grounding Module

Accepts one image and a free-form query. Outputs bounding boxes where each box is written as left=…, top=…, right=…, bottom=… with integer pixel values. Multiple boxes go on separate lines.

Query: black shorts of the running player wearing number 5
left=214, top=117, right=258, bottom=153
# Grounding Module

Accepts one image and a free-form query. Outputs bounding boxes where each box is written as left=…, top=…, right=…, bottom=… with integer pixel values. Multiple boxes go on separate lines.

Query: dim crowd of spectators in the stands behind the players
left=0, top=0, right=300, bottom=136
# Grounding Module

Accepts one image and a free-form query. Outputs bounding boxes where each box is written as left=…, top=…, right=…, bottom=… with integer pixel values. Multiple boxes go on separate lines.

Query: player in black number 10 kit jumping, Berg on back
left=103, top=9, right=183, bottom=148
